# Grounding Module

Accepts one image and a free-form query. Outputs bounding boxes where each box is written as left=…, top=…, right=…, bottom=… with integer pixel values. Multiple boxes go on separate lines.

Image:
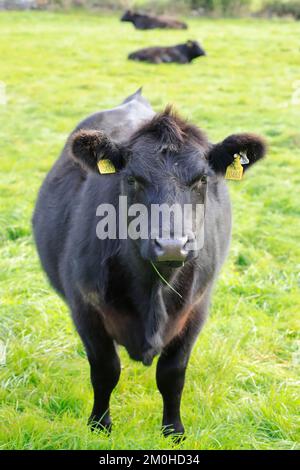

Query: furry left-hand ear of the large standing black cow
left=71, top=130, right=128, bottom=173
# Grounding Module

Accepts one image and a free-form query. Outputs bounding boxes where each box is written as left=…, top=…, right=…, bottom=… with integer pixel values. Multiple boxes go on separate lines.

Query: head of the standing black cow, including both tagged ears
left=72, top=107, right=265, bottom=267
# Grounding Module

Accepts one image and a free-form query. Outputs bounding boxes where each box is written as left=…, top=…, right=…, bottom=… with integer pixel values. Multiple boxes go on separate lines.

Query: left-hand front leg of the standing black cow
left=73, top=308, right=121, bottom=432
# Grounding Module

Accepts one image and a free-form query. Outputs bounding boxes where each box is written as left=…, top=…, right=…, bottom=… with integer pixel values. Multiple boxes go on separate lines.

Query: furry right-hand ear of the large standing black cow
left=208, top=134, right=267, bottom=175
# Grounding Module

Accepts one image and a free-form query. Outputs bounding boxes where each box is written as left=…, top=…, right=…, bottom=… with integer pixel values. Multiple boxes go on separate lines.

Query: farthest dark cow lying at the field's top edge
left=121, top=10, right=187, bottom=29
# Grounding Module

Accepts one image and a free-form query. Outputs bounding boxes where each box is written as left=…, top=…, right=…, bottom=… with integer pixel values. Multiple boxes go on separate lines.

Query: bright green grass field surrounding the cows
left=0, top=12, right=300, bottom=449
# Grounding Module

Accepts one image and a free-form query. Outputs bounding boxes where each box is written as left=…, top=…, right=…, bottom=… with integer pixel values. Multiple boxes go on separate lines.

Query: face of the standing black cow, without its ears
left=122, top=115, right=213, bottom=267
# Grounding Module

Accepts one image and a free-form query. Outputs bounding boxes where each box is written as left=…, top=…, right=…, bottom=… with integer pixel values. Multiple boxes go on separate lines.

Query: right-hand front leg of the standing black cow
left=156, top=305, right=207, bottom=441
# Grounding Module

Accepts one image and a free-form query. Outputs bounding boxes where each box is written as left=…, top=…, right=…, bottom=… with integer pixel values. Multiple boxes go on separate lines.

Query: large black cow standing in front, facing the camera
left=33, top=90, right=265, bottom=434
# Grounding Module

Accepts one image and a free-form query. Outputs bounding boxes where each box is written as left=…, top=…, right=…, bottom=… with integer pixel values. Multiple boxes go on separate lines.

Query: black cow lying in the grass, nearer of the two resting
left=128, top=41, right=206, bottom=64
